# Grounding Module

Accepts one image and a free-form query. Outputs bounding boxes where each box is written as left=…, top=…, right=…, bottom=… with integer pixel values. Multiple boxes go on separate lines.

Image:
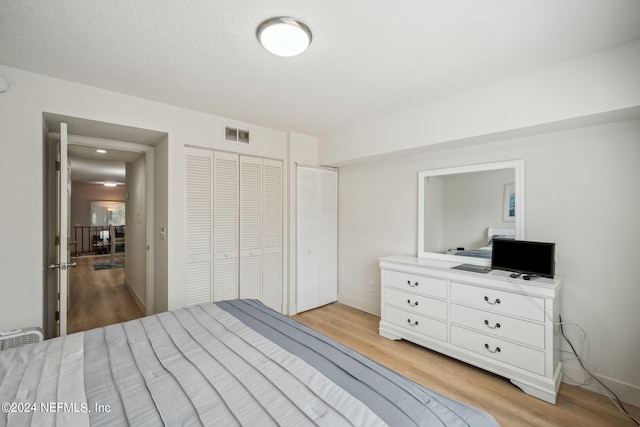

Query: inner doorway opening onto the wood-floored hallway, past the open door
left=67, top=145, right=142, bottom=333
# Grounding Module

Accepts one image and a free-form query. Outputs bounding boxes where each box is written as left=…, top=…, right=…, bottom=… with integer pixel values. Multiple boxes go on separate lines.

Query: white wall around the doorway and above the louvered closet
left=0, top=65, right=288, bottom=330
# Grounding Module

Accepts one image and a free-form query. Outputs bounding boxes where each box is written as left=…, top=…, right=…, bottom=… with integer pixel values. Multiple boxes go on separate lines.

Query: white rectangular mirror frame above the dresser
left=418, top=159, right=525, bottom=266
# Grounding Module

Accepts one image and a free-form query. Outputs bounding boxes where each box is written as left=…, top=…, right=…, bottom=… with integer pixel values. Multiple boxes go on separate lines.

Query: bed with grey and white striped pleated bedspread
left=0, top=300, right=498, bottom=426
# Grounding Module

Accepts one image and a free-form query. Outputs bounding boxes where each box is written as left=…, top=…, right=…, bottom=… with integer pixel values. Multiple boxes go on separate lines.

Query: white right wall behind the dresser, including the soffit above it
left=319, top=41, right=640, bottom=405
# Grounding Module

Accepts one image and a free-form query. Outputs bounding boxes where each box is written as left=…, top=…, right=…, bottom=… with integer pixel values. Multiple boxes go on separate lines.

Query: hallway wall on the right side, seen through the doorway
left=125, top=155, right=147, bottom=313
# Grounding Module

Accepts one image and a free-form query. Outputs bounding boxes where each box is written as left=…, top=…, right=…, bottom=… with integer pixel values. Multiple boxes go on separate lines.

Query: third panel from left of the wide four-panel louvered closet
left=240, top=156, right=262, bottom=299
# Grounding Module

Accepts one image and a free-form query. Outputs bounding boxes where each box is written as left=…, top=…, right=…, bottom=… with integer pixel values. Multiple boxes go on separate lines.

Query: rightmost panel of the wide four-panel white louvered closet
left=262, top=159, right=283, bottom=312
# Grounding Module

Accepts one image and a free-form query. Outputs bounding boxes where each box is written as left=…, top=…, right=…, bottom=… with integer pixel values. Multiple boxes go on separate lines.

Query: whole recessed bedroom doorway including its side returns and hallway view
left=43, top=113, right=168, bottom=337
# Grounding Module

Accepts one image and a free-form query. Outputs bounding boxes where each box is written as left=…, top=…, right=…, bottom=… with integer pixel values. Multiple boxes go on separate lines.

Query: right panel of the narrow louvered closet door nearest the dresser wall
left=317, top=169, right=338, bottom=305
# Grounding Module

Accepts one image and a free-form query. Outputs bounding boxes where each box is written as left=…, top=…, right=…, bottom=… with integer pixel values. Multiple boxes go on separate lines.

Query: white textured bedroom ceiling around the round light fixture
left=0, top=0, right=640, bottom=137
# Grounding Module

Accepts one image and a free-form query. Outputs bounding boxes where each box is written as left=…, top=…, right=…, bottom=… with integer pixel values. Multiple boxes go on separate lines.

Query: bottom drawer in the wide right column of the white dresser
left=451, top=326, right=545, bottom=375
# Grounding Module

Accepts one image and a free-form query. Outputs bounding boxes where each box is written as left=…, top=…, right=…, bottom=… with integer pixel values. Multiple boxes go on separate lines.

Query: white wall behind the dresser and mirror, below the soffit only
left=332, top=119, right=640, bottom=405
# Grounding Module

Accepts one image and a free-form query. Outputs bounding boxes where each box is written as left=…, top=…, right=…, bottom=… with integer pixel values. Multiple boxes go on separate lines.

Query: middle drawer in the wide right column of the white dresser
left=451, top=304, right=544, bottom=349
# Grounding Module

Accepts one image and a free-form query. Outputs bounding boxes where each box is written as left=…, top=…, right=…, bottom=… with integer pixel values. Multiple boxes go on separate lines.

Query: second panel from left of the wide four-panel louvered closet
left=213, top=151, right=239, bottom=301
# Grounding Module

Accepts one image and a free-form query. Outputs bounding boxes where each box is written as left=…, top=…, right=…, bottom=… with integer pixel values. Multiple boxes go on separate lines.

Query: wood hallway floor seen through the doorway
left=67, top=256, right=143, bottom=333
